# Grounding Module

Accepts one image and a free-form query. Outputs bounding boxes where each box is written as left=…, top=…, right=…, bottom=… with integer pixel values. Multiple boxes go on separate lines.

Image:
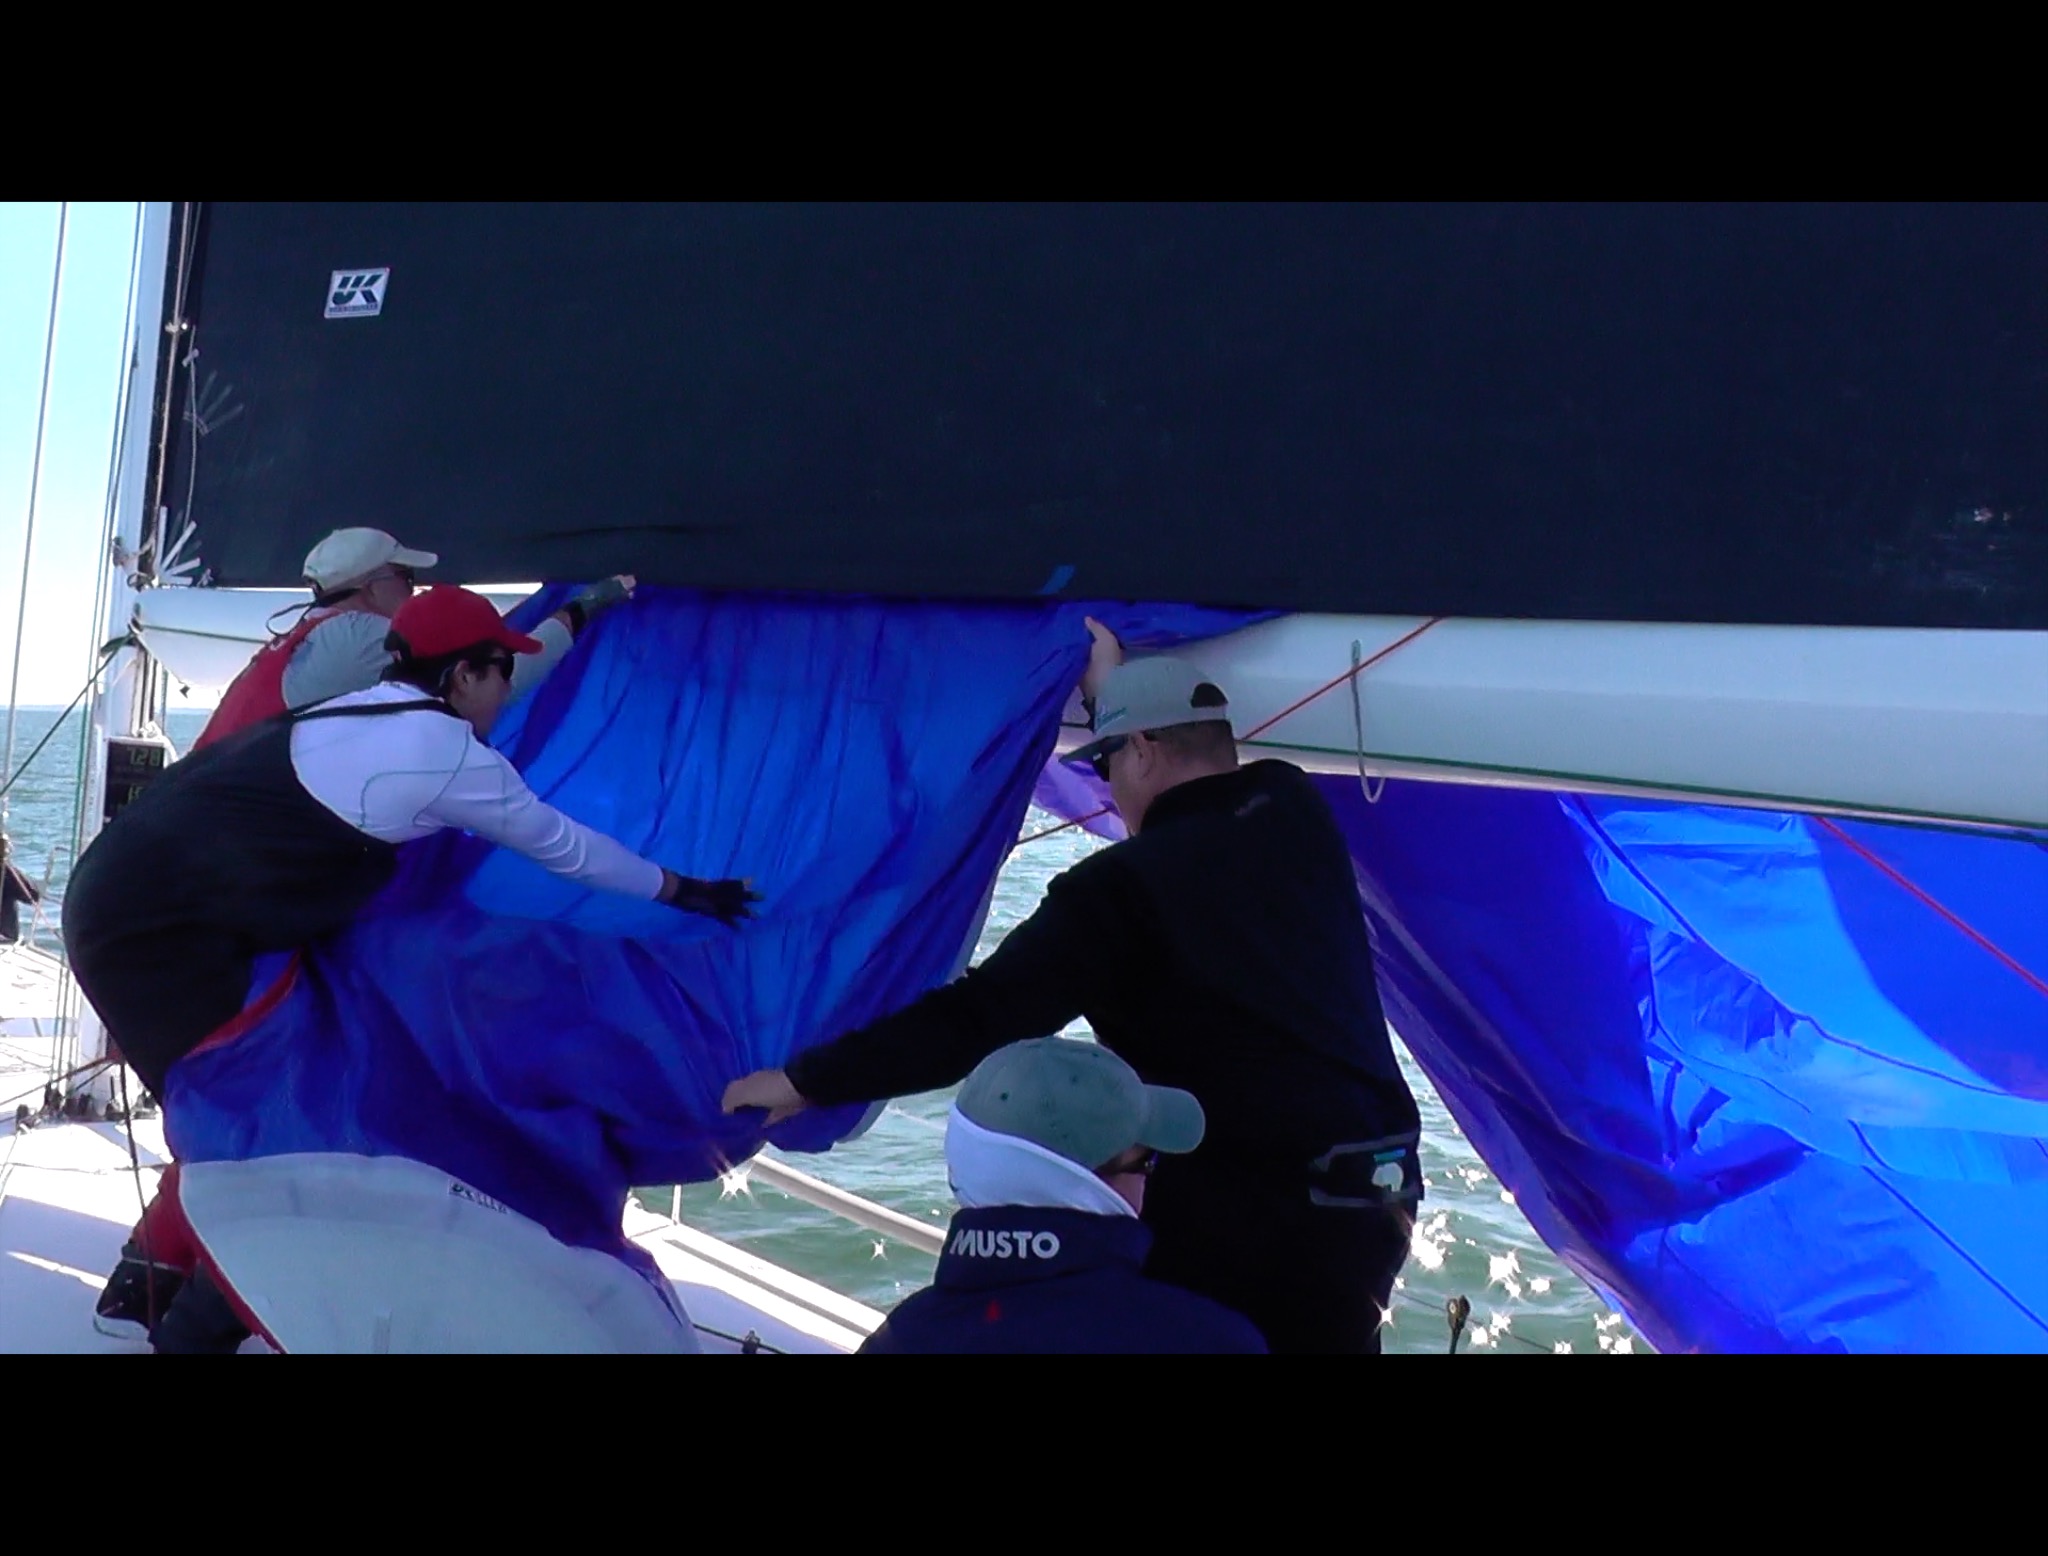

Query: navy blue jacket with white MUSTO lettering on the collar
left=860, top=1206, right=1266, bottom=1355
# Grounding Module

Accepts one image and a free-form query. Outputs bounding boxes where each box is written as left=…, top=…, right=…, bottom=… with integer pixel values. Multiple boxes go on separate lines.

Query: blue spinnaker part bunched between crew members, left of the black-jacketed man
left=166, top=590, right=1253, bottom=1257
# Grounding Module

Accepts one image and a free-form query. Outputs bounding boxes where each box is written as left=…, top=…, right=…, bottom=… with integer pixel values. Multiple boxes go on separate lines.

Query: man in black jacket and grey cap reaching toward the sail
left=725, top=618, right=1421, bottom=1353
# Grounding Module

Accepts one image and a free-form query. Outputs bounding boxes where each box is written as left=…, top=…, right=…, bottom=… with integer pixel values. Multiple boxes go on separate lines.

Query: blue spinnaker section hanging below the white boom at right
left=1038, top=768, right=2048, bottom=1351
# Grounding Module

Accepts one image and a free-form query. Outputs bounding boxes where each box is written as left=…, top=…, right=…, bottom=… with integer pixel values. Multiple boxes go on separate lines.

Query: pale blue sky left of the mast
left=0, top=201, right=135, bottom=706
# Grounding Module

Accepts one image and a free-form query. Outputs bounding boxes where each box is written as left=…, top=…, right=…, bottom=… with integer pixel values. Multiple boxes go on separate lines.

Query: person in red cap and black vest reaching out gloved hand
left=63, top=584, right=760, bottom=1351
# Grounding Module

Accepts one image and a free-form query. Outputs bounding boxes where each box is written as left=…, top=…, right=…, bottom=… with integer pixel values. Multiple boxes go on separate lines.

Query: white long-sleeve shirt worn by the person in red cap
left=291, top=682, right=664, bottom=901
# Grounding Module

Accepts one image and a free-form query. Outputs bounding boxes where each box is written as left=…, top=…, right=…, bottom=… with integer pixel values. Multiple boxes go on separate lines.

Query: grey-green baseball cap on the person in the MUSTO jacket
left=954, top=1038, right=1206, bottom=1171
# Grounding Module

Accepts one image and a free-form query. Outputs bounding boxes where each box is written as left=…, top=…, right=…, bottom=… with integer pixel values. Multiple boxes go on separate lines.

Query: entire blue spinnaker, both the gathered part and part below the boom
left=168, top=592, right=2048, bottom=1351
